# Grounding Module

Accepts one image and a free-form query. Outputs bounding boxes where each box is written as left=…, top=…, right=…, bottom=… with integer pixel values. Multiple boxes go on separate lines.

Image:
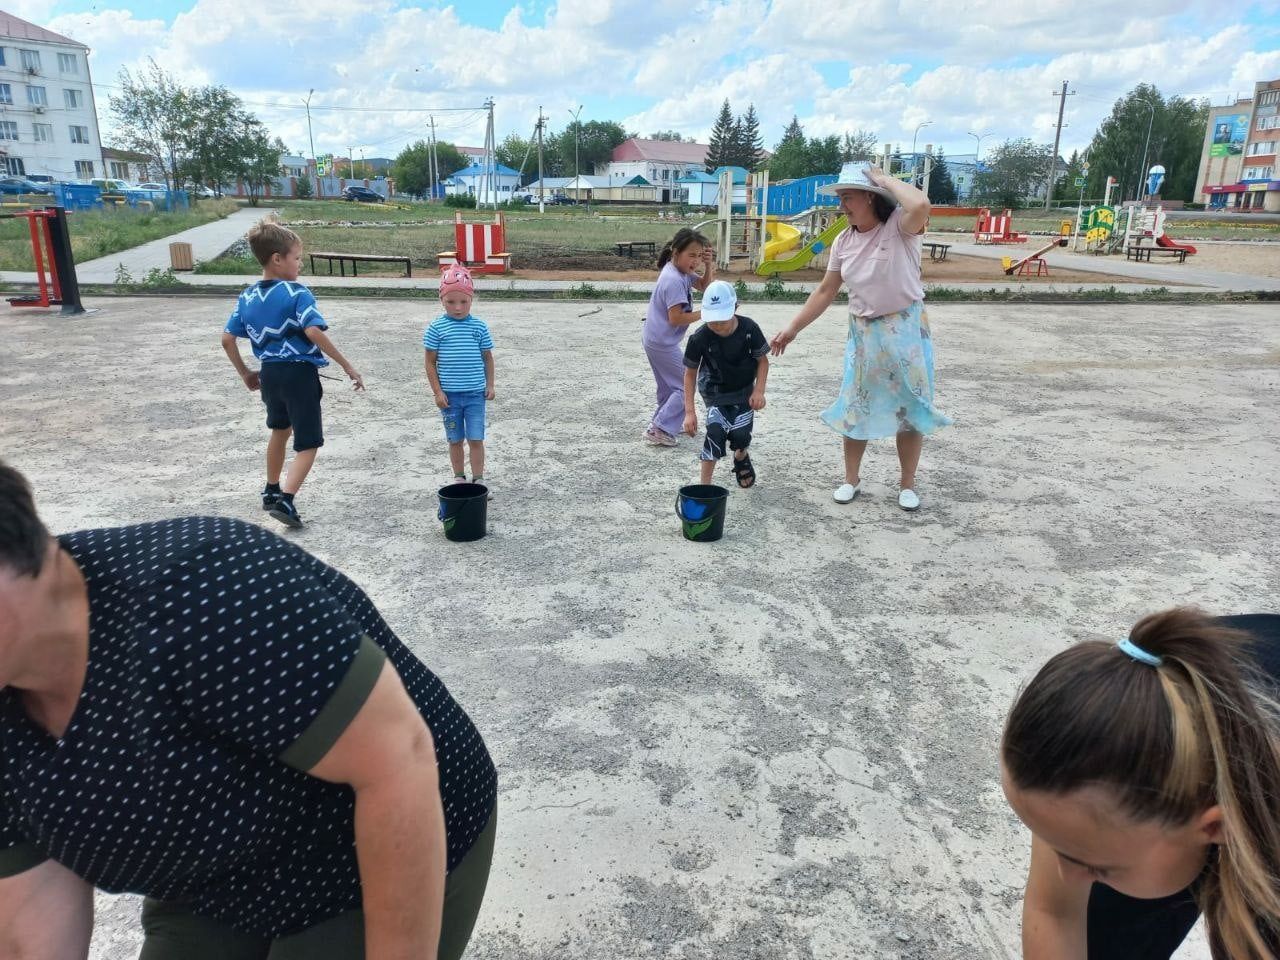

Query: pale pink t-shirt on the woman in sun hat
left=827, top=207, right=924, bottom=317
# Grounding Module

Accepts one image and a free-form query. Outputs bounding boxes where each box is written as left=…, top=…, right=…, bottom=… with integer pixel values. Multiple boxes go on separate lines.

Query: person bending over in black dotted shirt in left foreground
left=0, top=463, right=497, bottom=960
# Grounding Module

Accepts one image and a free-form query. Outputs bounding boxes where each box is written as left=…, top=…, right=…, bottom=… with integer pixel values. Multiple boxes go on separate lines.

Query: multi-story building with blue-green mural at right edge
left=1196, top=79, right=1280, bottom=212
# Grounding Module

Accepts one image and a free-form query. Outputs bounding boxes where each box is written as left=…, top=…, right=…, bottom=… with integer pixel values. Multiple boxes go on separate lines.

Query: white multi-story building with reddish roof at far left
left=0, top=12, right=108, bottom=180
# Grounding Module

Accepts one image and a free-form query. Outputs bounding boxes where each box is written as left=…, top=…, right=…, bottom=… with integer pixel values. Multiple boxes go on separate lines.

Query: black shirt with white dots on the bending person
left=0, top=517, right=497, bottom=937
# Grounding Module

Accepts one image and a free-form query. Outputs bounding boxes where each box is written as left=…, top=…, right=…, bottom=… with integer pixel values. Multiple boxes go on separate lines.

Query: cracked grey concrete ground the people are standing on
left=0, top=298, right=1280, bottom=960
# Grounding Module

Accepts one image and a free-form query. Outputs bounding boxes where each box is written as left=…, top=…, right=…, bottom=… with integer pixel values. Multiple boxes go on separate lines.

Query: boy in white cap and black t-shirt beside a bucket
left=685, top=280, right=769, bottom=488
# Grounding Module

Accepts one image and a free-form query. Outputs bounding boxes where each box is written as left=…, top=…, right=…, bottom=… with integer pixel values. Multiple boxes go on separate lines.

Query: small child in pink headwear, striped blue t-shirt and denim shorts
left=422, top=266, right=493, bottom=484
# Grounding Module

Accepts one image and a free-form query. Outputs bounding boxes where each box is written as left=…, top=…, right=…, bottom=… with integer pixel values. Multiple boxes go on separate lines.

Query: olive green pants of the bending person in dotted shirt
left=138, top=808, right=498, bottom=960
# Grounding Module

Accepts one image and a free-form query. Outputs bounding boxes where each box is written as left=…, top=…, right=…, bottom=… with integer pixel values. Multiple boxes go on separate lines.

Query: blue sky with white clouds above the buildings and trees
left=24, top=0, right=1280, bottom=163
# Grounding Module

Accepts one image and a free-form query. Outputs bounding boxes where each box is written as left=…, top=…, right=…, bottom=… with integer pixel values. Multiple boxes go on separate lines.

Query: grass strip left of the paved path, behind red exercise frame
left=0, top=198, right=239, bottom=270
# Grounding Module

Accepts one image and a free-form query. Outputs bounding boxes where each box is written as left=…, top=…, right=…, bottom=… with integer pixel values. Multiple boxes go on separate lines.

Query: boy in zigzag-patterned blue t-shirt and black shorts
left=223, top=218, right=365, bottom=527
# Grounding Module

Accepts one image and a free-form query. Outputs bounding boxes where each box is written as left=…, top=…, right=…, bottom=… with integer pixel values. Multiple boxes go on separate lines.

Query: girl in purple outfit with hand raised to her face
left=640, top=227, right=716, bottom=447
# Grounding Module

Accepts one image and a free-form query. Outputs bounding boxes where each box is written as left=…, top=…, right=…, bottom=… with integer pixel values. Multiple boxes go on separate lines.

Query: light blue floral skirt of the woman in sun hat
left=822, top=301, right=951, bottom=440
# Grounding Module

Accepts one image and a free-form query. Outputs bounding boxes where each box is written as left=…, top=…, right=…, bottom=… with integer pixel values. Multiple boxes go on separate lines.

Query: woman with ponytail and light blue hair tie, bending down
left=1001, top=609, right=1280, bottom=960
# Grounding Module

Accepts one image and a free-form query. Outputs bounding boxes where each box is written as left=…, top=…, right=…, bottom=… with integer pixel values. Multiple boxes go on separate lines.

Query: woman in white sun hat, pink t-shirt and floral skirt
left=772, top=163, right=951, bottom=511
